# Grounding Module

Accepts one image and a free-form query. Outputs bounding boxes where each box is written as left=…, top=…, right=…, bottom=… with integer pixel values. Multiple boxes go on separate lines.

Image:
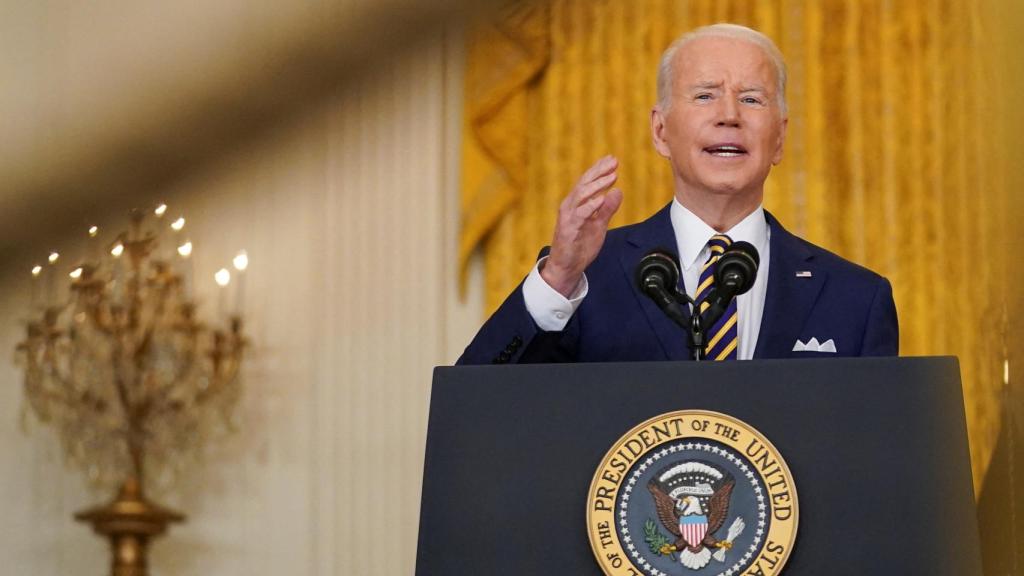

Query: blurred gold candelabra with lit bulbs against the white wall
left=16, top=206, right=248, bottom=576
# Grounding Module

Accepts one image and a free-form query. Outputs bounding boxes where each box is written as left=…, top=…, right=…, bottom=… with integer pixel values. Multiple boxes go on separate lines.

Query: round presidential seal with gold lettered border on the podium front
left=587, top=410, right=799, bottom=576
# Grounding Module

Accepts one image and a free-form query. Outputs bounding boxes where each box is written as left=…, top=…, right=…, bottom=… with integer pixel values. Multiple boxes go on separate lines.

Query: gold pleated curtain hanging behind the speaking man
left=462, top=0, right=1019, bottom=494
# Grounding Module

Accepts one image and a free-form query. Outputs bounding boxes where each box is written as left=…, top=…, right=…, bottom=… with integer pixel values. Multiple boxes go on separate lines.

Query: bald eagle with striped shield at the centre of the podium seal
left=646, top=460, right=745, bottom=570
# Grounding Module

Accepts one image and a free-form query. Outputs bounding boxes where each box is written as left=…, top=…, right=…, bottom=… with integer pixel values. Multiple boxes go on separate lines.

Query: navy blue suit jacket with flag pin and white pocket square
left=459, top=206, right=899, bottom=364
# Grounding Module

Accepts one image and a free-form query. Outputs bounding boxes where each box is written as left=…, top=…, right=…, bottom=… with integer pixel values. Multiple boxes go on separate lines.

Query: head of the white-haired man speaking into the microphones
left=651, top=37, right=785, bottom=207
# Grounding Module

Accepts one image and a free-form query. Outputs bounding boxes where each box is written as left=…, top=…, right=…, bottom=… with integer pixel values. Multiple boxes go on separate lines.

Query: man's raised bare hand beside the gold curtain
left=541, top=156, right=623, bottom=297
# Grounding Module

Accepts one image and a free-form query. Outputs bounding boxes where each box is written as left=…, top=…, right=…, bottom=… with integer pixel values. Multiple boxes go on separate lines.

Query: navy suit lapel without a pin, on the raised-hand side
left=620, top=204, right=689, bottom=360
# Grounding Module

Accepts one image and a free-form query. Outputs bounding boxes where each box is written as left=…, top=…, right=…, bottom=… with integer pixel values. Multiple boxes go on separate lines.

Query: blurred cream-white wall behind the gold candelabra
left=0, top=25, right=482, bottom=576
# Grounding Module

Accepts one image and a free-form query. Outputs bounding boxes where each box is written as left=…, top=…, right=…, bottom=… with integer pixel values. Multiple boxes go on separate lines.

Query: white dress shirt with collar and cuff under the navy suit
left=522, top=200, right=771, bottom=360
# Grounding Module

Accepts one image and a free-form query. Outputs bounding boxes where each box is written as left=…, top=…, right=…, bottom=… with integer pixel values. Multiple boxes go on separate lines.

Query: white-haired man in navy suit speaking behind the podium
left=459, top=25, right=899, bottom=364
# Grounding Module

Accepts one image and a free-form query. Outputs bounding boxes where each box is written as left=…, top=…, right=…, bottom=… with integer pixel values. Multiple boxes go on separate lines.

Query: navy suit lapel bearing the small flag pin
left=754, top=211, right=825, bottom=359
